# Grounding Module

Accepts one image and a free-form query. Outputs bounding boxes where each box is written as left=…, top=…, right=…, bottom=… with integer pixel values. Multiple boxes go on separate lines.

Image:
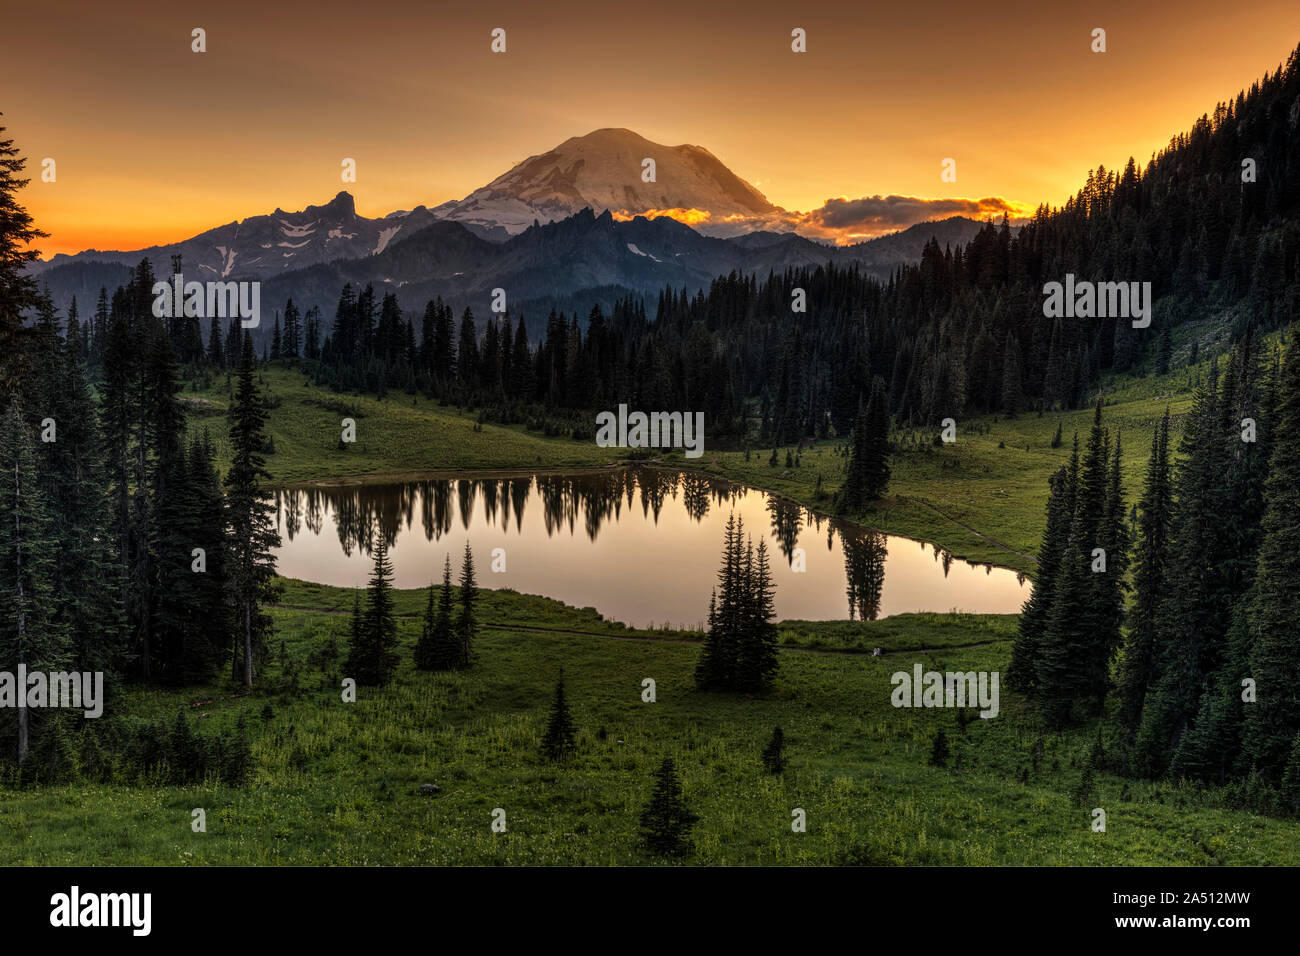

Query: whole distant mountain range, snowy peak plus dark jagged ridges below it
left=31, top=130, right=982, bottom=327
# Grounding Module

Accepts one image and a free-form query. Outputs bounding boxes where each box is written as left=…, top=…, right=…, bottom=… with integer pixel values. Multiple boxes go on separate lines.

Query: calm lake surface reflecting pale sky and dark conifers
left=276, top=468, right=1030, bottom=627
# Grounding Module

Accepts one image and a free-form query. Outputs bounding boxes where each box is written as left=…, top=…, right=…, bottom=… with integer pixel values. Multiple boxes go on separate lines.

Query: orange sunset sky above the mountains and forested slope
left=0, top=0, right=1300, bottom=258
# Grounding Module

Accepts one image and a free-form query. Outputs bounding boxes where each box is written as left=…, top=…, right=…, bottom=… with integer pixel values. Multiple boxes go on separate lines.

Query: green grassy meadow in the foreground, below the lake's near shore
left=0, top=574, right=1300, bottom=865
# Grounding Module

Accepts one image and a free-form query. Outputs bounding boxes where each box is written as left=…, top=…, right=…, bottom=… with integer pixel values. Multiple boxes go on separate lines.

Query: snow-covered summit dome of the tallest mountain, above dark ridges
left=434, top=129, right=777, bottom=235
